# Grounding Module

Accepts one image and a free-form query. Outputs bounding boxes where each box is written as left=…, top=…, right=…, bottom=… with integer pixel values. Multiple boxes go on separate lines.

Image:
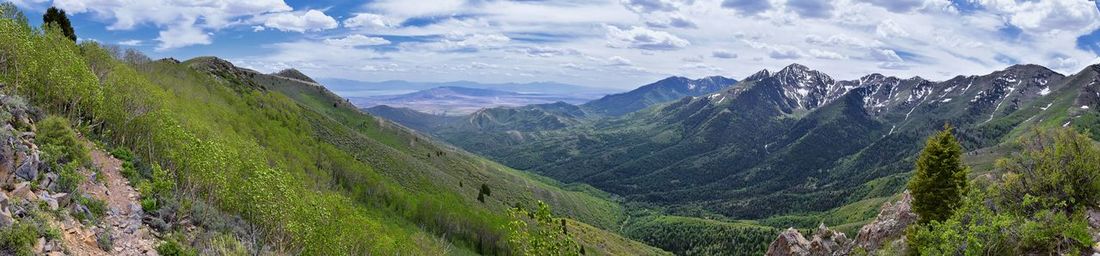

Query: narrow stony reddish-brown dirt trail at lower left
left=64, top=143, right=156, bottom=255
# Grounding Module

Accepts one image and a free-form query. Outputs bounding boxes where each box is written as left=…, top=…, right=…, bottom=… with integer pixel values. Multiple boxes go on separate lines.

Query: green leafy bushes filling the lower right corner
left=908, top=129, right=1100, bottom=255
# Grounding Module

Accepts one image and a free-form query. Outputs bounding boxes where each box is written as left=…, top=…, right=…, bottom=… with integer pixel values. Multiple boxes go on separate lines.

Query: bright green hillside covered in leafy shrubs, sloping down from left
left=0, top=9, right=660, bottom=255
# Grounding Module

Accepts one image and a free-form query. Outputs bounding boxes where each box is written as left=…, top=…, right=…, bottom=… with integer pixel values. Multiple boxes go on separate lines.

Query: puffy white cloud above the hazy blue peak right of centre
left=605, top=25, right=691, bottom=51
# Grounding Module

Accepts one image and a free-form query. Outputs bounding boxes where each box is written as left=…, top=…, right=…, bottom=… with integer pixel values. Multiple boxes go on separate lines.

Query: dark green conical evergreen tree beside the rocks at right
left=909, top=125, right=969, bottom=223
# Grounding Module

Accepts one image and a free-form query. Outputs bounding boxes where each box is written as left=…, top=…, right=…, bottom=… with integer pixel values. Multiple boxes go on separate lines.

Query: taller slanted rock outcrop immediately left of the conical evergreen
left=856, top=191, right=916, bottom=252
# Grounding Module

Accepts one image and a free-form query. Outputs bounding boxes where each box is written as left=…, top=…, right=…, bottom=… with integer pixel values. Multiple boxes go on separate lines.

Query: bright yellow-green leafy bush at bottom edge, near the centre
left=506, top=201, right=581, bottom=255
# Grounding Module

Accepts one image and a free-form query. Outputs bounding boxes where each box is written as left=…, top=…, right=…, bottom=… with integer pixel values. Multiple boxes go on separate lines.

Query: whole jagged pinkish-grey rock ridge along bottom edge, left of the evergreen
left=766, top=191, right=916, bottom=256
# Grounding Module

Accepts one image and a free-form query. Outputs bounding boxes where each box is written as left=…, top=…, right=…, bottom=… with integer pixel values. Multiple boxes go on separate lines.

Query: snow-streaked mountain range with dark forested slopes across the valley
left=372, top=64, right=1100, bottom=220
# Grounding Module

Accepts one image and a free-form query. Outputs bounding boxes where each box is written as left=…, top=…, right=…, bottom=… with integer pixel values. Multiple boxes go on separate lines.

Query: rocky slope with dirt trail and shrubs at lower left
left=0, top=92, right=160, bottom=255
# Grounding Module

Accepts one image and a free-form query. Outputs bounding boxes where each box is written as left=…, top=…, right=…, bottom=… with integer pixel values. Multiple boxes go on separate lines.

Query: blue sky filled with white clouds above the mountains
left=6, top=0, right=1100, bottom=89
